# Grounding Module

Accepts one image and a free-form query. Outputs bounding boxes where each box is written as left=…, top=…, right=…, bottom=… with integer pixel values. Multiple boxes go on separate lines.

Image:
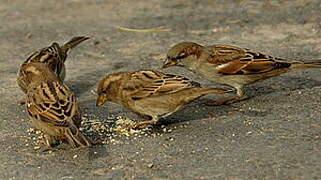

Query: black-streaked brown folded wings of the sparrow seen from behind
left=27, top=82, right=80, bottom=127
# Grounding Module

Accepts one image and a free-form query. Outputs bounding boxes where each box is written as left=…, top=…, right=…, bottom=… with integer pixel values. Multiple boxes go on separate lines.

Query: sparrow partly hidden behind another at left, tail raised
left=18, top=36, right=89, bottom=93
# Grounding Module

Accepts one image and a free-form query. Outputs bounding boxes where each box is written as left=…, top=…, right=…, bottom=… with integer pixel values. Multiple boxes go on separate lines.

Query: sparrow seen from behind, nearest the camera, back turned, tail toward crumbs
left=21, top=62, right=91, bottom=148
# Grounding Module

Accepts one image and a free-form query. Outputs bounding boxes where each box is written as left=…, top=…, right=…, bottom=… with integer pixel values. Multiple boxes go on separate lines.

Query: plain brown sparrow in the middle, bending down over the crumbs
left=96, top=70, right=229, bottom=128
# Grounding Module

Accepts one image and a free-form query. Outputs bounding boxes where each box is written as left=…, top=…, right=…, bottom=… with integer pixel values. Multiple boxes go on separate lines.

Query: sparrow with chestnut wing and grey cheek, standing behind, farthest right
left=163, top=42, right=321, bottom=105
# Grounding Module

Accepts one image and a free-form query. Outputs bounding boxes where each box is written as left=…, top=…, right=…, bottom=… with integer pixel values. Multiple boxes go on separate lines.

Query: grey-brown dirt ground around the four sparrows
left=0, top=0, right=321, bottom=179
